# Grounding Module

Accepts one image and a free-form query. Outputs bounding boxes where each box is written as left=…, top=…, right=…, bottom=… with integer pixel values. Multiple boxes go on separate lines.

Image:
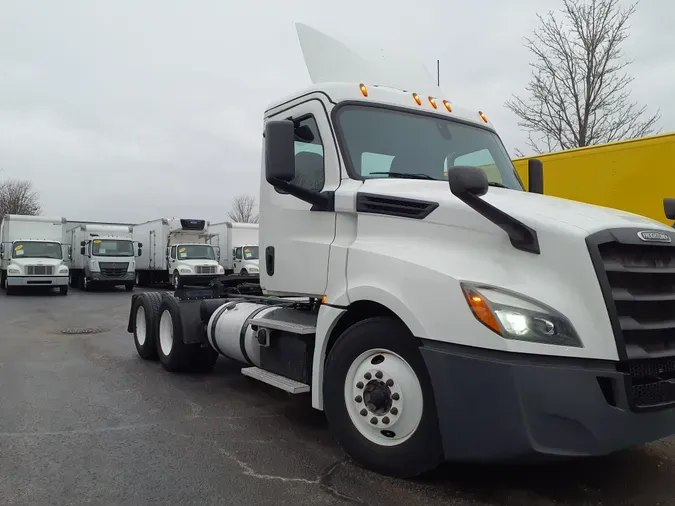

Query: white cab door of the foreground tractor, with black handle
left=260, top=94, right=340, bottom=297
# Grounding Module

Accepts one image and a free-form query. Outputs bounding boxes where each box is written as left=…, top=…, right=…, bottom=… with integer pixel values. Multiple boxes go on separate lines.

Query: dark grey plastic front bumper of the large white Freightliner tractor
left=420, top=340, right=675, bottom=462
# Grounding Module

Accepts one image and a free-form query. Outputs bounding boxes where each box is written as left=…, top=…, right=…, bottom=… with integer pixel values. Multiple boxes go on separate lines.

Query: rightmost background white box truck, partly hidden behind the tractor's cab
left=209, top=221, right=260, bottom=276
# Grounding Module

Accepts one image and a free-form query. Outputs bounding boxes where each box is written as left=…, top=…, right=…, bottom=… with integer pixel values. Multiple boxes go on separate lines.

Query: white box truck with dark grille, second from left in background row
left=67, top=223, right=143, bottom=292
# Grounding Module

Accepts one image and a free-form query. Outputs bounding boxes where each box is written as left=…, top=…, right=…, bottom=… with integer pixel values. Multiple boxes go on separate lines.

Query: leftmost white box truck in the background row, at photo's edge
left=0, top=214, right=68, bottom=295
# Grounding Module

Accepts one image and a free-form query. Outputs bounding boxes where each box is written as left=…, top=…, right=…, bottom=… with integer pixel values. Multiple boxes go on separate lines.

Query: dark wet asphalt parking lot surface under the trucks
left=0, top=290, right=675, bottom=506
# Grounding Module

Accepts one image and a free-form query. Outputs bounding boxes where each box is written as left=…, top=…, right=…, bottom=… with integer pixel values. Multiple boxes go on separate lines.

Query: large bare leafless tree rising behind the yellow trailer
left=506, top=0, right=661, bottom=153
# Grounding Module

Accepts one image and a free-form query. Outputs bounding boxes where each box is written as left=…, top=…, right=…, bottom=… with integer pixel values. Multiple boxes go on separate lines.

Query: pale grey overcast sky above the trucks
left=0, top=0, right=675, bottom=222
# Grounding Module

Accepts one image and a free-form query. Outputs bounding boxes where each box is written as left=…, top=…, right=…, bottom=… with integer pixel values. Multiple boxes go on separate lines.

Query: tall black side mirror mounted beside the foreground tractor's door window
left=265, top=119, right=295, bottom=186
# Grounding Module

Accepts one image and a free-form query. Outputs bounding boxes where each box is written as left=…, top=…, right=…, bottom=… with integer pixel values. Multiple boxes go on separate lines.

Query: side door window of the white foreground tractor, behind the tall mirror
left=278, top=116, right=326, bottom=193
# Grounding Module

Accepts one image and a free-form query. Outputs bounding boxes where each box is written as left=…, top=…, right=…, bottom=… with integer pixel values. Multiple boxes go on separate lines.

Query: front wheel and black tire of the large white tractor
left=323, top=317, right=443, bottom=478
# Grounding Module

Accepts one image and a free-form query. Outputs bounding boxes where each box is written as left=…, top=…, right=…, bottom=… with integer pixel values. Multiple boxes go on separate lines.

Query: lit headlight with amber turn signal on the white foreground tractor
left=462, top=283, right=584, bottom=348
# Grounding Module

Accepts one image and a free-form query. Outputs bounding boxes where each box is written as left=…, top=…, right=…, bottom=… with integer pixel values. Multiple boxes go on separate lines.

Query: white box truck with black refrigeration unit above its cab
left=133, top=218, right=224, bottom=288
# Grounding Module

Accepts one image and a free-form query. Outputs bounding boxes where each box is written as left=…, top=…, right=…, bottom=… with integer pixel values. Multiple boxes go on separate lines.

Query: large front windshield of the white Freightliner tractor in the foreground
left=337, top=105, right=523, bottom=190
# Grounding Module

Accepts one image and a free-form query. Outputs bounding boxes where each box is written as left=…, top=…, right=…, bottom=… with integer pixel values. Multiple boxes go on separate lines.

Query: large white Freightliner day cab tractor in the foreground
left=128, top=25, right=675, bottom=477
